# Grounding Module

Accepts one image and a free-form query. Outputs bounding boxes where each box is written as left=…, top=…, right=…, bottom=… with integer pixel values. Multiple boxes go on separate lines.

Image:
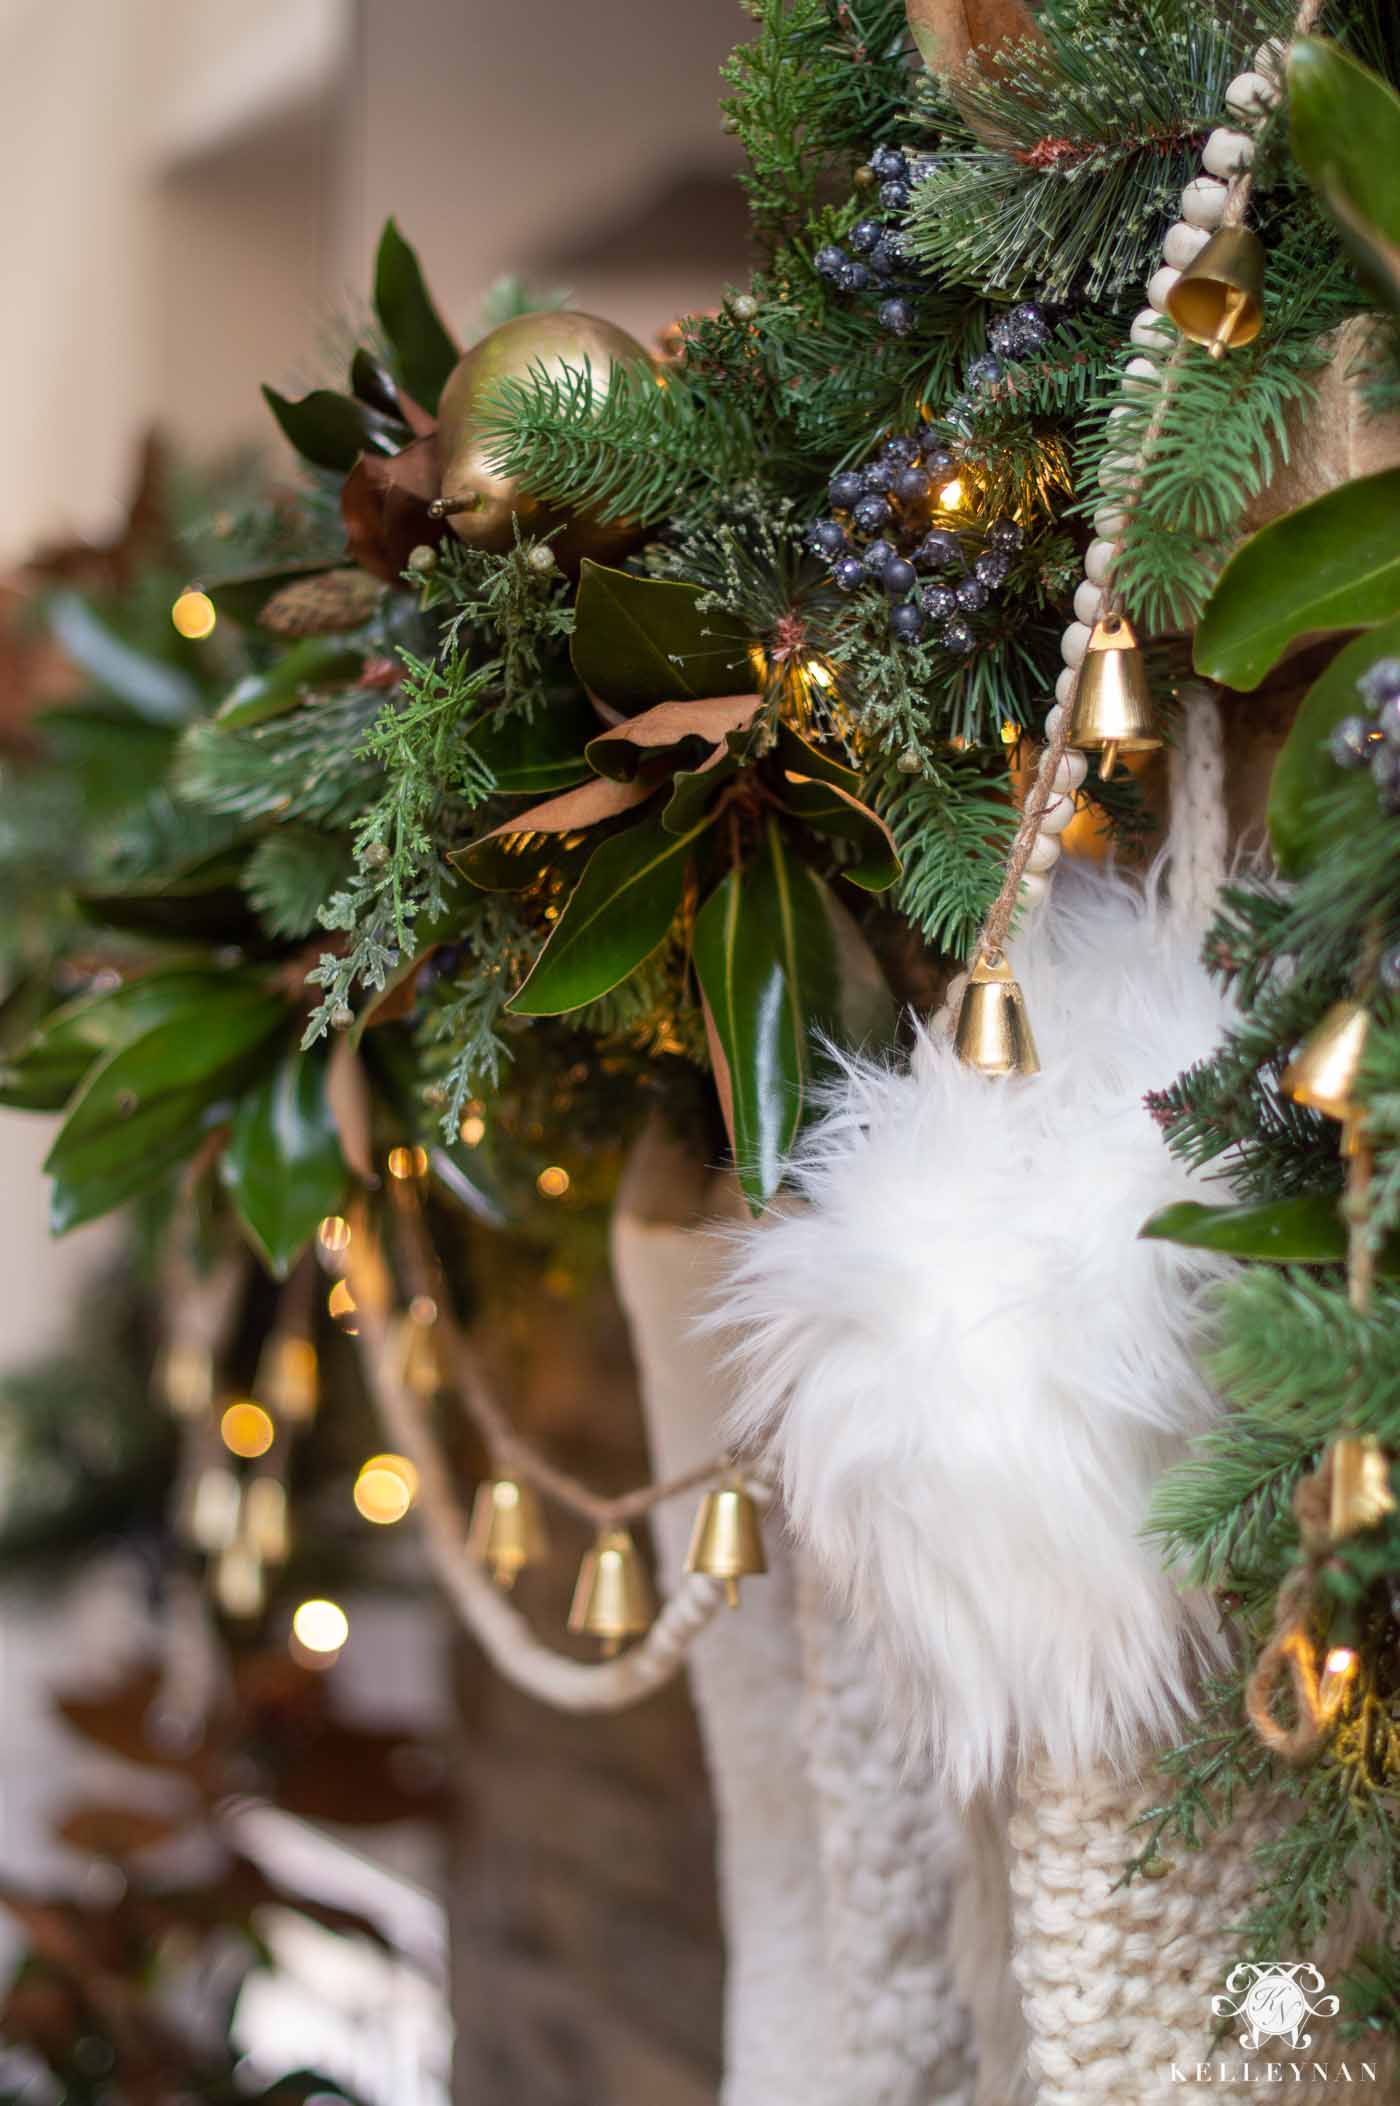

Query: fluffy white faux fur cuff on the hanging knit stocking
left=714, top=870, right=1227, bottom=1794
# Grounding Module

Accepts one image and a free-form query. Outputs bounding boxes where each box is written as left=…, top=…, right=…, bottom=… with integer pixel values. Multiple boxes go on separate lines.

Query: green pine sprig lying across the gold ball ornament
left=482, top=360, right=756, bottom=522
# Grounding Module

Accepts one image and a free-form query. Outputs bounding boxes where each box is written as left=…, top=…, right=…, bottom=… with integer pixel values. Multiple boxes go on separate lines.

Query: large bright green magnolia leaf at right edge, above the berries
left=1196, top=468, right=1400, bottom=689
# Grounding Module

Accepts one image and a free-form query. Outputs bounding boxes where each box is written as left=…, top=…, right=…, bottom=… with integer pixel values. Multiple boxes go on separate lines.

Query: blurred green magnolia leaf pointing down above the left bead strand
left=219, top=1049, right=349, bottom=1280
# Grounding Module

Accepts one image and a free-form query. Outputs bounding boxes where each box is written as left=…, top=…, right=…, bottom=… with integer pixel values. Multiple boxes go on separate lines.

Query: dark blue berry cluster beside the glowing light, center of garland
left=806, top=425, right=1023, bottom=655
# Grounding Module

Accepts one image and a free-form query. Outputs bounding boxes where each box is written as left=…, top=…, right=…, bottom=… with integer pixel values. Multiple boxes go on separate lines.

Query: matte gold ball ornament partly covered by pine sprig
left=438, top=310, right=653, bottom=567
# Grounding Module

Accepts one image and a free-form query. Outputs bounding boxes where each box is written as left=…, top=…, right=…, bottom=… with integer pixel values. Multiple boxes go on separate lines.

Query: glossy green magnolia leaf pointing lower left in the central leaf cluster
left=507, top=819, right=709, bottom=1017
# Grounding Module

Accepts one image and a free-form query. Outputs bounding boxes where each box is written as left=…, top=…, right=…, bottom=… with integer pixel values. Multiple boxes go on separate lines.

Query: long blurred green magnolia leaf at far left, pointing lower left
left=44, top=981, right=286, bottom=1184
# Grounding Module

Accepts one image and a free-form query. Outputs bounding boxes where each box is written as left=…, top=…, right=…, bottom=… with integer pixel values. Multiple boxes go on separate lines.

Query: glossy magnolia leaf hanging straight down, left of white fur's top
left=695, top=819, right=840, bottom=1211
